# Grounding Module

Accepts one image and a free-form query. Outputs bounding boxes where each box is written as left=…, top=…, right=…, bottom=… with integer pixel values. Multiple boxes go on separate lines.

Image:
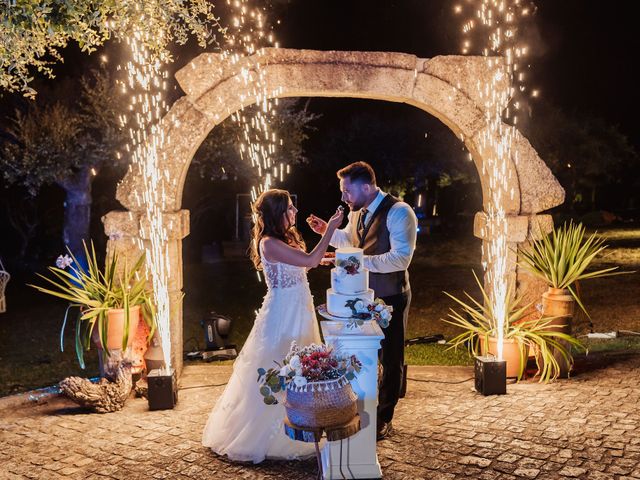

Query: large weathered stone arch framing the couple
left=103, top=49, right=564, bottom=371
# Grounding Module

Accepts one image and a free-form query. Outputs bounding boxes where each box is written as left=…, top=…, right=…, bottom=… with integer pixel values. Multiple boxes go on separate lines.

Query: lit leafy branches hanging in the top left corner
left=0, top=0, right=222, bottom=97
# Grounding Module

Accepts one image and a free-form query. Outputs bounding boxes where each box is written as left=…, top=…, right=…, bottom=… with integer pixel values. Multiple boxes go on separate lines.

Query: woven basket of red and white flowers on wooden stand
left=258, top=342, right=361, bottom=428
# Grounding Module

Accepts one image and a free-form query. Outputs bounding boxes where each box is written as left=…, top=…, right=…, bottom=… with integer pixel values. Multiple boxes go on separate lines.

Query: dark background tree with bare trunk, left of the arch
left=0, top=69, right=125, bottom=258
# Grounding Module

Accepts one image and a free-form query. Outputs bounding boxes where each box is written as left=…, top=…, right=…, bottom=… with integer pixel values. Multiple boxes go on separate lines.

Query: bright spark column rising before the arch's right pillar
left=454, top=0, right=538, bottom=359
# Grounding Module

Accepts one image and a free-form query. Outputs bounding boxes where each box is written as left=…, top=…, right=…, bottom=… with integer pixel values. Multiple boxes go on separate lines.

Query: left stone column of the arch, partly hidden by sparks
left=102, top=210, right=189, bottom=375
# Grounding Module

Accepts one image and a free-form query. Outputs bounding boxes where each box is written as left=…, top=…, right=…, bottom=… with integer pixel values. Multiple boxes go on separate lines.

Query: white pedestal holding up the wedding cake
left=321, top=321, right=384, bottom=480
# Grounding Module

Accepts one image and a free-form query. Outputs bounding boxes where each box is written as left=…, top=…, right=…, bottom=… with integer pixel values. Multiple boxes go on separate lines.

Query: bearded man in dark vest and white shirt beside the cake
left=307, top=162, right=418, bottom=440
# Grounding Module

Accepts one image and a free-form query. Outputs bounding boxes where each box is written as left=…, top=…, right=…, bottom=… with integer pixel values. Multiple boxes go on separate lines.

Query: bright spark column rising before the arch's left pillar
left=111, top=0, right=224, bottom=369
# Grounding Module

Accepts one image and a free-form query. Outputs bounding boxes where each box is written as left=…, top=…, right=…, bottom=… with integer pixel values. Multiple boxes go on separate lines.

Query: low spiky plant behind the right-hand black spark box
left=442, top=272, right=584, bottom=382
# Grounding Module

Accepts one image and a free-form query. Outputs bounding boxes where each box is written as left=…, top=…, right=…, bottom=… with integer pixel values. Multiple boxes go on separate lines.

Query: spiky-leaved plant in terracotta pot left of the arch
left=29, top=242, right=156, bottom=368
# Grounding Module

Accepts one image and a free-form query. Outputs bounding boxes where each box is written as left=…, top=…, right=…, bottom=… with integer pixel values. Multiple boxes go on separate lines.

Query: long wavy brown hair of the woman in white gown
left=250, top=188, right=307, bottom=270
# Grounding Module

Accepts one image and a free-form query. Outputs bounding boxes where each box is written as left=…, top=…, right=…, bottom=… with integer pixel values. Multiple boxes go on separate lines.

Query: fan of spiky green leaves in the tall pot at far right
left=520, top=222, right=632, bottom=318
